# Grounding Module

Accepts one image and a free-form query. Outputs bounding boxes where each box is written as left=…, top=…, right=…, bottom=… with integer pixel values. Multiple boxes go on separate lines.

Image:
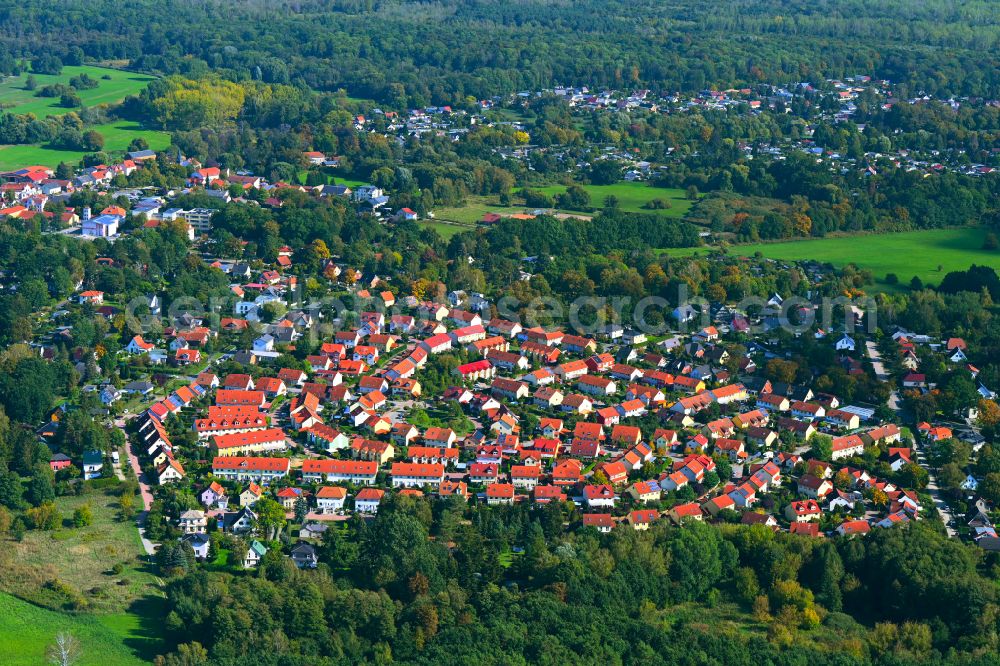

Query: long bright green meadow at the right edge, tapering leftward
left=663, top=227, right=1000, bottom=284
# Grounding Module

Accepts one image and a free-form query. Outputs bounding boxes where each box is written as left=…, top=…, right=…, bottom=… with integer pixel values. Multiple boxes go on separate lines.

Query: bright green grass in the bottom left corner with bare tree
left=0, top=592, right=163, bottom=666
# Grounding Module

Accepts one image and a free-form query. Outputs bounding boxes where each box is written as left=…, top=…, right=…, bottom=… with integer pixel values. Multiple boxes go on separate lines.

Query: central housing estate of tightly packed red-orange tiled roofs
left=50, top=255, right=980, bottom=567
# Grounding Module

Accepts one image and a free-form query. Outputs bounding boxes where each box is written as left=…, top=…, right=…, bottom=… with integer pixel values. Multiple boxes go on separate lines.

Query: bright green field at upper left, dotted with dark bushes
left=0, top=65, right=153, bottom=118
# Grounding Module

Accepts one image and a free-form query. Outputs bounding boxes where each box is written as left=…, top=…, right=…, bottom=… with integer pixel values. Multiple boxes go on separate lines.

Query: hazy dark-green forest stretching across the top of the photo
left=0, top=0, right=1000, bottom=106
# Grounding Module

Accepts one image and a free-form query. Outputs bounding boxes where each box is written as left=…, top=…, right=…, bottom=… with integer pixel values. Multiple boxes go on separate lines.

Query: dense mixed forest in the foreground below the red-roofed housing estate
left=150, top=498, right=996, bottom=666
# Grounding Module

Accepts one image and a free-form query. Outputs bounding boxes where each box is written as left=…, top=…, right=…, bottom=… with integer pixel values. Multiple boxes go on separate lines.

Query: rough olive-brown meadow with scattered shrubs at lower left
left=0, top=482, right=161, bottom=612
